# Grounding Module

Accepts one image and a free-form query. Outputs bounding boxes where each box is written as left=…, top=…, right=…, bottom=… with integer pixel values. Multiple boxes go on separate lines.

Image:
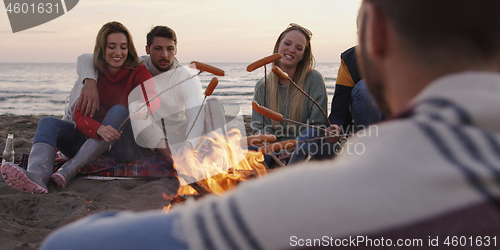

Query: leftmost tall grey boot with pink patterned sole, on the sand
left=0, top=143, right=56, bottom=194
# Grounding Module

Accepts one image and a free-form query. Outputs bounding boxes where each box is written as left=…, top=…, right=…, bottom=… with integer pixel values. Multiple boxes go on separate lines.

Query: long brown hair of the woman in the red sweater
left=94, top=21, right=139, bottom=74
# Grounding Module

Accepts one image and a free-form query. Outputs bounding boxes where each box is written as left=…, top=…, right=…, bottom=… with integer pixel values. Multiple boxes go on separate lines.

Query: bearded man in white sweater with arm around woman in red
left=63, top=26, right=224, bottom=163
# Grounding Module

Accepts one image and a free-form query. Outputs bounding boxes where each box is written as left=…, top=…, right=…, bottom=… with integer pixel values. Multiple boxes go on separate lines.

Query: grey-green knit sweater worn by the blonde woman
left=252, top=70, right=328, bottom=141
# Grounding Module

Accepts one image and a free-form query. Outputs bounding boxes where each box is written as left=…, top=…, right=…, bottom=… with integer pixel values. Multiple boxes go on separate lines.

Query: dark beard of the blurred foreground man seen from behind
left=356, top=12, right=392, bottom=117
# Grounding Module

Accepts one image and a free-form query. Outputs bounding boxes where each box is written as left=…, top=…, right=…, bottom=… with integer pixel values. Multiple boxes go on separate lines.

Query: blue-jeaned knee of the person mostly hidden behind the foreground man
left=351, top=80, right=382, bottom=131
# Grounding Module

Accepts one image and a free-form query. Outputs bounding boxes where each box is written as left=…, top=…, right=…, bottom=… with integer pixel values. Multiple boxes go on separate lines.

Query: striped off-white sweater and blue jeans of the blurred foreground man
left=42, top=72, right=500, bottom=250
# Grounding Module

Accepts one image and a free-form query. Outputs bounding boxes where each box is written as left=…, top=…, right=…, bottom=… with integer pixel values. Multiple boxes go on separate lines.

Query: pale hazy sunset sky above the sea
left=0, top=0, right=361, bottom=63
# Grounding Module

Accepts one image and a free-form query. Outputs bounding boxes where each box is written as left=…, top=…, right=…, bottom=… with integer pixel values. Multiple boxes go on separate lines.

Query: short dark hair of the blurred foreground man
left=364, top=0, right=500, bottom=65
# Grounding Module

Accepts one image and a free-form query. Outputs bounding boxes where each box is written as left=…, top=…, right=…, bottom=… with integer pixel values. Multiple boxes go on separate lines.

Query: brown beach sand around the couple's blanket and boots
left=0, top=115, right=254, bottom=249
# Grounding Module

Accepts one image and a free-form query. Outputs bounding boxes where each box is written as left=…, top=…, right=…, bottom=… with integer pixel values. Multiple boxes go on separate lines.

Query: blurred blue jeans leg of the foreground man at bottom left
left=40, top=211, right=188, bottom=250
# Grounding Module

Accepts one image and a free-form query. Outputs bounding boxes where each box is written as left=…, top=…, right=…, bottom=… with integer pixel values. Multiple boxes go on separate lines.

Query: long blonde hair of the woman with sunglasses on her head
left=266, top=24, right=316, bottom=126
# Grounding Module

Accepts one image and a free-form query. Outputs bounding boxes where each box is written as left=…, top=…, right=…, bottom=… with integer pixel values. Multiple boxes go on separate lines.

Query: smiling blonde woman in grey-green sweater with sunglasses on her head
left=252, top=24, right=327, bottom=166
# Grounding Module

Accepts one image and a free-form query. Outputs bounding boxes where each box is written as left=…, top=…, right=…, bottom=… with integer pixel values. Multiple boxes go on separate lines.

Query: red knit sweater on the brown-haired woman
left=75, top=65, right=159, bottom=139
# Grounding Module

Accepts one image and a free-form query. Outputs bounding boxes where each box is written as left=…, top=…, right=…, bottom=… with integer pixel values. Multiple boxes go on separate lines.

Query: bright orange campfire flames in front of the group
left=163, top=128, right=267, bottom=213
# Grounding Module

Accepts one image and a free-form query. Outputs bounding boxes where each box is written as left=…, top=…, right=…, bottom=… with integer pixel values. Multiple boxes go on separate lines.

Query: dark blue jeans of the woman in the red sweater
left=33, top=105, right=152, bottom=163
